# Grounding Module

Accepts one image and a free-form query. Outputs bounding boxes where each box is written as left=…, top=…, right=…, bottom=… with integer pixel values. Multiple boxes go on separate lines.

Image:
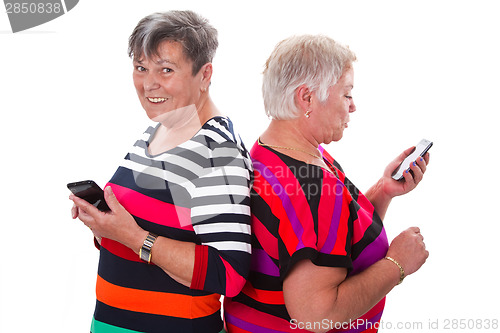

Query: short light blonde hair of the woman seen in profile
left=262, top=35, right=356, bottom=120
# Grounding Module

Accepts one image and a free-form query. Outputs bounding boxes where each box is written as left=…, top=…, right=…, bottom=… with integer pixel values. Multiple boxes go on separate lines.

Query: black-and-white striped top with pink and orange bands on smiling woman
left=91, top=117, right=252, bottom=333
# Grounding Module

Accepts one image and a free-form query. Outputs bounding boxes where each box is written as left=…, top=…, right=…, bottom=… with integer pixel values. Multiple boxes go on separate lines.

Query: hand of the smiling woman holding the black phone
left=69, top=186, right=142, bottom=245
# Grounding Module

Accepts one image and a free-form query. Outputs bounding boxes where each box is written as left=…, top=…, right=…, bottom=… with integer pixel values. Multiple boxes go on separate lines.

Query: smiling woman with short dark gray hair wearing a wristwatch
left=70, top=11, right=251, bottom=333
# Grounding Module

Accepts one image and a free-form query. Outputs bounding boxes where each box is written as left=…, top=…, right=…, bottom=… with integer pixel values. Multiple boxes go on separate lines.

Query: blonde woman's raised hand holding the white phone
left=381, top=147, right=429, bottom=198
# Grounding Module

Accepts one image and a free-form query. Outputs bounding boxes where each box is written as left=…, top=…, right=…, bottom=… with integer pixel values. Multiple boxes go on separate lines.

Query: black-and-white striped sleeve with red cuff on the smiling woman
left=191, top=119, right=251, bottom=296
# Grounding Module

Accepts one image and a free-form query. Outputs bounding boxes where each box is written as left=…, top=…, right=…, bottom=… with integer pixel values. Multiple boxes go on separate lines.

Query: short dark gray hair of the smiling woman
left=128, top=10, right=219, bottom=75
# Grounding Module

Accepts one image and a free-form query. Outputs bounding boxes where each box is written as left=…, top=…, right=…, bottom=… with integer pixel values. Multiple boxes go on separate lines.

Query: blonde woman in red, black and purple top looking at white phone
left=224, top=35, right=429, bottom=333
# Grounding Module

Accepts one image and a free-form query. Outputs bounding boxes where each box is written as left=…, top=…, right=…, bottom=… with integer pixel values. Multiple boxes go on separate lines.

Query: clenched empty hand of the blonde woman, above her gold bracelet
left=387, top=227, right=429, bottom=275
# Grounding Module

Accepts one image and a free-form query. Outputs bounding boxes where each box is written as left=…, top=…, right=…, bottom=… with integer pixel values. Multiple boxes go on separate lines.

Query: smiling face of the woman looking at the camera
left=133, top=41, right=202, bottom=120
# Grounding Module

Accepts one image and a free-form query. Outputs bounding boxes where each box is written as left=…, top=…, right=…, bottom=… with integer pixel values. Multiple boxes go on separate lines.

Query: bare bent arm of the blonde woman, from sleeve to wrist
left=283, top=259, right=400, bottom=332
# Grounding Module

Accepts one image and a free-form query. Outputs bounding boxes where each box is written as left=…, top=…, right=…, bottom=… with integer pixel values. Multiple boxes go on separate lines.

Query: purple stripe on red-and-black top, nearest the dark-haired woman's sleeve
left=252, top=158, right=304, bottom=250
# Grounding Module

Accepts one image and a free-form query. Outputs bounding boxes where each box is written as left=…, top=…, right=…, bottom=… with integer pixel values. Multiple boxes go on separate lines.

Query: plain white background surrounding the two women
left=0, top=0, right=500, bottom=332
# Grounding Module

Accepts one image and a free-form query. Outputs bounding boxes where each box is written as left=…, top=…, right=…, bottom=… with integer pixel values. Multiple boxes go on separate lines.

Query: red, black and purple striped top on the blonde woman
left=224, top=143, right=388, bottom=333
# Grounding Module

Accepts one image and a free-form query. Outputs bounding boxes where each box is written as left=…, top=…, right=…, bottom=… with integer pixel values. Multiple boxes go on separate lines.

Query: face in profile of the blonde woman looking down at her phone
left=311, top=67, right=356, bottom=144
